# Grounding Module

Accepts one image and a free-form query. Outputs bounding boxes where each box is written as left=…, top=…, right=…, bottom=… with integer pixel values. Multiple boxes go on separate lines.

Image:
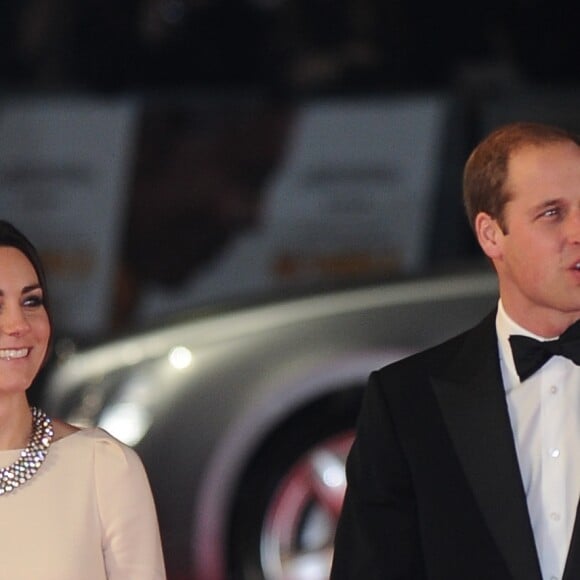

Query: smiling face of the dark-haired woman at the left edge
left=0, top=246, right=50, bottom=396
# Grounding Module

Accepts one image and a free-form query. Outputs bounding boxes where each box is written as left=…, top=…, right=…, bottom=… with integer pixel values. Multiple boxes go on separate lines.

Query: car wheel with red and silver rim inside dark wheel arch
left=229, top=389, right=361, bottom=580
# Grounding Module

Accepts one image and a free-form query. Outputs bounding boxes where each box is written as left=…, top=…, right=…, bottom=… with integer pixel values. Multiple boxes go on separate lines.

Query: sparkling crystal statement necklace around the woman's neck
left=0, top=407, right=54, bottom=496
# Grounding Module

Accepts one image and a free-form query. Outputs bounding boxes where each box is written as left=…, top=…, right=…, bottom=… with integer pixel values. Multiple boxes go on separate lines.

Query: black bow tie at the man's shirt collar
left=509, top=320, right=580, bottom=381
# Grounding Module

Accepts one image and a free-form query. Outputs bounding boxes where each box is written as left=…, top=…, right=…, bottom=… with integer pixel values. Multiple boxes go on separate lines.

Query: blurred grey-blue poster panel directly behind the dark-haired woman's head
left=0, top=97, right=138, bottom=337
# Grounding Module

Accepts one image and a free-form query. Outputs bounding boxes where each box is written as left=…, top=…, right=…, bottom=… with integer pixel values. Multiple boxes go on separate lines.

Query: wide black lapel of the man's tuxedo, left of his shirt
left=432, top=316, right=541, bottom=580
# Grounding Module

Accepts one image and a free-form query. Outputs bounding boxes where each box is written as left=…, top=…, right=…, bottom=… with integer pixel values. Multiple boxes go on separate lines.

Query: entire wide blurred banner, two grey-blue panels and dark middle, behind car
left=0, top=94, right=450, bottom=330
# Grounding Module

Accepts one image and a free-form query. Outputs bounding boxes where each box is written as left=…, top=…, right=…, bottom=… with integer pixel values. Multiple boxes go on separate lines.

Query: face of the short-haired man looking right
left=484, top=143, right=580, bottom=336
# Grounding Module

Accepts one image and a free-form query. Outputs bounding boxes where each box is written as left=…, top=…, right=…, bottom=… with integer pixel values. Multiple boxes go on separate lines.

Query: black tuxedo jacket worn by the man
left=331, top=312, right=580, bottom=580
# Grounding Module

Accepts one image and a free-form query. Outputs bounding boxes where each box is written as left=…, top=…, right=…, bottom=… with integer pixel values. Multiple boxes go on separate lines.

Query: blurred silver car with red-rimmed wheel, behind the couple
left=44, top=271, right=497, bottom=580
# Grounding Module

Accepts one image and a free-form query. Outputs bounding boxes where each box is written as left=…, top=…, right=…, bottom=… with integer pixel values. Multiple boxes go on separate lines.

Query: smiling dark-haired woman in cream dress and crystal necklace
left=0, top=220, right=165, bottom=580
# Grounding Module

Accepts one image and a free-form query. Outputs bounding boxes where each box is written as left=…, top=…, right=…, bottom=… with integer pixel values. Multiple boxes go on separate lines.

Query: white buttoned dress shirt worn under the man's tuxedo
left=496, top=300, right=580, bottom=580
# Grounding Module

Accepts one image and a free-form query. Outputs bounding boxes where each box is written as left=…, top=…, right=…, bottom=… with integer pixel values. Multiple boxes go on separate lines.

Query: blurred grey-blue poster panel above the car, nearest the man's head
left=264, top=96, right=447, bottom=281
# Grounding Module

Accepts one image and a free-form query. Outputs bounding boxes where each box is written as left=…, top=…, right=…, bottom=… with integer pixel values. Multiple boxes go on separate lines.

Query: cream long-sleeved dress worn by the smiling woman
left=0, top=429, right=165, bottom=580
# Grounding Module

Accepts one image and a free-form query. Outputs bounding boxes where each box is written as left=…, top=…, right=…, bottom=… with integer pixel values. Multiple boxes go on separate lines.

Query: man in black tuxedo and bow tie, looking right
left=331, top=123, right=580, bottom=580
